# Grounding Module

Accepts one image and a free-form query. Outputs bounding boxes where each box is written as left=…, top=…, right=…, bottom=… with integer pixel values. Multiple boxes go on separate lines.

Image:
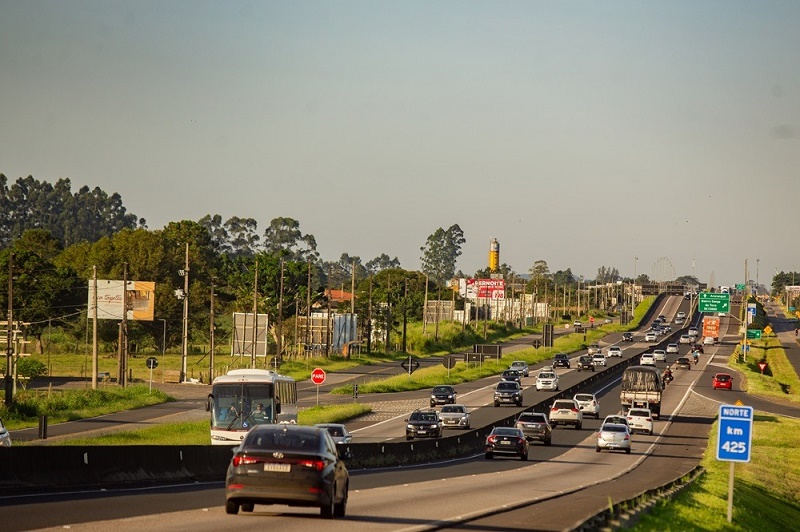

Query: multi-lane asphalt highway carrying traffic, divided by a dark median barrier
left=0, top=298, right=764, bottom=531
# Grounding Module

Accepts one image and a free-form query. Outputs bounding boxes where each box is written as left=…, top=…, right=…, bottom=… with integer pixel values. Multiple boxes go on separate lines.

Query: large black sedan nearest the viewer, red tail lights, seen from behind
left=225, top=424, right=350, bottom=518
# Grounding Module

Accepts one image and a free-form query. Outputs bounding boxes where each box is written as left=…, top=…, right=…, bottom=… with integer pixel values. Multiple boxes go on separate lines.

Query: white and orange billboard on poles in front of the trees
left=89, top=279, right=156, bottom=321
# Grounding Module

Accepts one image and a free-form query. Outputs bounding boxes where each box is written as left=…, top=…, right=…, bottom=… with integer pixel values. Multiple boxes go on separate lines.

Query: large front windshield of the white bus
left=211, top=383, right=276, bottom=430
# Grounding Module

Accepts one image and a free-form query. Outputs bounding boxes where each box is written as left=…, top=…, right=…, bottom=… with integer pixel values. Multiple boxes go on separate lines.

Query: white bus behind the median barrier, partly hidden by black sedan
left=206, top=369, right=297, bottom=445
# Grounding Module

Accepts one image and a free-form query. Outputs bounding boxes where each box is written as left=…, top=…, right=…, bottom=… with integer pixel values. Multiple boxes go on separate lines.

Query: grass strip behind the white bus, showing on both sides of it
left=49, top=403, right=372, bottom=445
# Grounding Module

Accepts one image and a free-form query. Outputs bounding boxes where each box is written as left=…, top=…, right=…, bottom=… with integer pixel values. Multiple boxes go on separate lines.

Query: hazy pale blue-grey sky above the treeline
left=0, top=0, right=800, bottom=285
